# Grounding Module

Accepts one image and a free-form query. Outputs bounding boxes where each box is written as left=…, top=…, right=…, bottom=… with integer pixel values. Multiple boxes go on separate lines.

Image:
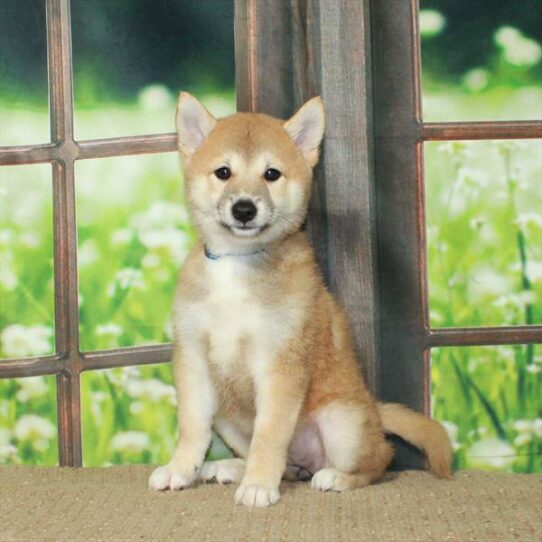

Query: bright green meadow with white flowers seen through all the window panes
left=0, top=3, right=542, bottom=472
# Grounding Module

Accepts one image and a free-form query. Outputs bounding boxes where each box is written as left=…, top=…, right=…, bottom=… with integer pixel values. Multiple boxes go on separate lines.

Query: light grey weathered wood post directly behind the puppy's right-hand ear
left=293, top=0, right=379, bottom=393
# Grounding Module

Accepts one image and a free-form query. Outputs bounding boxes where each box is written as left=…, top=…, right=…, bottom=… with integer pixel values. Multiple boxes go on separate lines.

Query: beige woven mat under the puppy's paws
left=0, top=466, right=542, bottom=542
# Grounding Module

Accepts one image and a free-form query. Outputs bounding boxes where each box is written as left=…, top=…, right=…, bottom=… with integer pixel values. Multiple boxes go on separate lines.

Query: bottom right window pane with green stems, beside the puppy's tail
left=431, top=345, right=542, bottom=472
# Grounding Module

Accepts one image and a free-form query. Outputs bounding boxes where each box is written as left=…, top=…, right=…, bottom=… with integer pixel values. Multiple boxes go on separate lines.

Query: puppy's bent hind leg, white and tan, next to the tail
left=311, top=402, right=392, bottom=491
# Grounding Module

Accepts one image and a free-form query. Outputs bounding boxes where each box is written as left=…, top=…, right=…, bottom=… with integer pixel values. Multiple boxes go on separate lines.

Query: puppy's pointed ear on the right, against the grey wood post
left=283, top=96, right=325, bottom=167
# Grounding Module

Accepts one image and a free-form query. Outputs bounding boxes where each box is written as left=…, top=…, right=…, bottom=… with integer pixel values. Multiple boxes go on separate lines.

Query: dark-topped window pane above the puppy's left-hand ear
left=71, top=0, right=235, bottom=139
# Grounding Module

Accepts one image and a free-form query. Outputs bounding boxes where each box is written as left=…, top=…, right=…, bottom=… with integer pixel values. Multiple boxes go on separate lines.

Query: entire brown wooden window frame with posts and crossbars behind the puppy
left=0, top=0, right=542, bottom=467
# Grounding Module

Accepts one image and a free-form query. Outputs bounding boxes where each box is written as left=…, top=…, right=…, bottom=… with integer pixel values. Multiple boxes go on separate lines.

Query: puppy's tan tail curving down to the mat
left=378, top=403, right=452, bottom=478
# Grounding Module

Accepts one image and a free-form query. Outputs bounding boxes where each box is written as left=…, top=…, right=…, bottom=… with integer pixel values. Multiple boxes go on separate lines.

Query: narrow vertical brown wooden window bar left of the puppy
left=46, top=0, right=82, bottom=466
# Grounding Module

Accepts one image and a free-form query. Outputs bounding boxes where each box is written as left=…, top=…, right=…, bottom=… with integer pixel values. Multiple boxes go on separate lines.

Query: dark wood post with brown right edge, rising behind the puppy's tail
left=371, top=0, right=430, bottom=467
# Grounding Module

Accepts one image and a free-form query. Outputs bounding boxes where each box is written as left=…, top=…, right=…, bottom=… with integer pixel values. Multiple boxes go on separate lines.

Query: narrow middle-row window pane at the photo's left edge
left=0, top=164, right=54, bottom=358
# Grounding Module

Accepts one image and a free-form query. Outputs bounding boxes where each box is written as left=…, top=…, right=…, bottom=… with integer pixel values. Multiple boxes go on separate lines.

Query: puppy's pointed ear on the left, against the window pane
left=175, top=92, right=216, bottom=159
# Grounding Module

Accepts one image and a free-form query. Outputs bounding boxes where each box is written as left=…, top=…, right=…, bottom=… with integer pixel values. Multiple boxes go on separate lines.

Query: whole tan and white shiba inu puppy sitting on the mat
left=149, top=93, right=451, bottom=506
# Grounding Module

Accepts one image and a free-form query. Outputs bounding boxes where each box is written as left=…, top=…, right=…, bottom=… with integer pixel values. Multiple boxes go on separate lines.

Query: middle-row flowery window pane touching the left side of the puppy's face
left=76, top=153, right=195, bottom=350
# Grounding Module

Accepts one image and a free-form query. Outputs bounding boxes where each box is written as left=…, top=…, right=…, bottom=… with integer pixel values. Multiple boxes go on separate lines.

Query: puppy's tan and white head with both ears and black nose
left=176, top=92, right=324, bottom=247
